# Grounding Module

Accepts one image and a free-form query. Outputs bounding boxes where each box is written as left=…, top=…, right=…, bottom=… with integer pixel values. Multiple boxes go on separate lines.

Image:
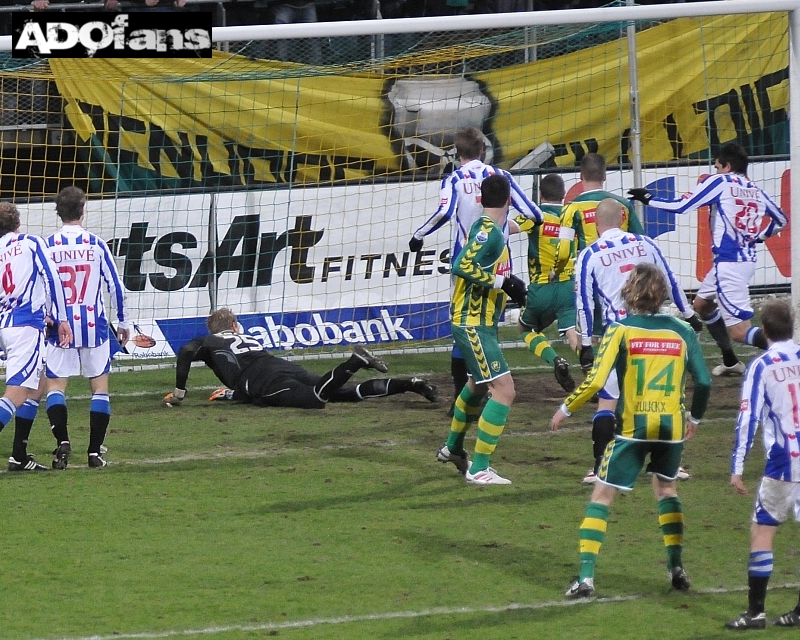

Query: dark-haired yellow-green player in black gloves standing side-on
left=436, top=175, right=526, bottom=485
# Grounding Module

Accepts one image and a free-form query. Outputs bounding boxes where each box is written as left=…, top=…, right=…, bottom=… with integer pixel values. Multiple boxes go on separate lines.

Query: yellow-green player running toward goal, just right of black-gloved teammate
left=514, top=173, right=580, bottom=391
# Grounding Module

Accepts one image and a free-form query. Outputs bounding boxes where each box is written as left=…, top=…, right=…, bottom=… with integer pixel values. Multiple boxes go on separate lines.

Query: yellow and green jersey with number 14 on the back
left=564, top=314, right=711, bottom=442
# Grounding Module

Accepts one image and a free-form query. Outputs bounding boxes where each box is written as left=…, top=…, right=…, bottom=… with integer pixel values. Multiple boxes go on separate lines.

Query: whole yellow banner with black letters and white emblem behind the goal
left=50, top=14, right=788, bottom=188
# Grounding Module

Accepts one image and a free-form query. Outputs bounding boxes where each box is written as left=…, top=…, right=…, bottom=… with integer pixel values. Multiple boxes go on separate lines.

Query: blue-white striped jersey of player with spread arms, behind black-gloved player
left=414, top=160, right=544, bottom=262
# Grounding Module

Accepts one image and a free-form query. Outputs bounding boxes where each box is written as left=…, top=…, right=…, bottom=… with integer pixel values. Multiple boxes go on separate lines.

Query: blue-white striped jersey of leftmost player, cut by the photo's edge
left=0, top=232, right=67, bottom=330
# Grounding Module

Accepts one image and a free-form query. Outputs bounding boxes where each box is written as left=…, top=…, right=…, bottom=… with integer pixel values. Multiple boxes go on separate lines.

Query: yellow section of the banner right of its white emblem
left=476, top=14, right=789, bottom=166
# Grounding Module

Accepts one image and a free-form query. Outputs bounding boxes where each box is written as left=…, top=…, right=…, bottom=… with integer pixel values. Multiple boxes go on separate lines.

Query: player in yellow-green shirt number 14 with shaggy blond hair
left=550, top=262, right=711, bottom=598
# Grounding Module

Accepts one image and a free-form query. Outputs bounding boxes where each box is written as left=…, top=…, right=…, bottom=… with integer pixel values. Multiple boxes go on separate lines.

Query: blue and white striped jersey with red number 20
left=649, top=173, right=787, bottom=262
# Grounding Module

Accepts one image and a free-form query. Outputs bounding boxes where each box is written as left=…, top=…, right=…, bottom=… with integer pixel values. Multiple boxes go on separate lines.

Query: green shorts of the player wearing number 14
left=597, top=437, right=683, bottom=490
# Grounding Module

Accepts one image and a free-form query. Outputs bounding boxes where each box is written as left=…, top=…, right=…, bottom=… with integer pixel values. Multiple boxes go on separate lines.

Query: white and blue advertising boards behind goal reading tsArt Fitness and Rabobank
left=15, top=162, right=791, bottom=358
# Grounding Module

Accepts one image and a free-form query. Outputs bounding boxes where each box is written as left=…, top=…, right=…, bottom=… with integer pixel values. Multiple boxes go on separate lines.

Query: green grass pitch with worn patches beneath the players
left=0, top=347, right=800, bottom=640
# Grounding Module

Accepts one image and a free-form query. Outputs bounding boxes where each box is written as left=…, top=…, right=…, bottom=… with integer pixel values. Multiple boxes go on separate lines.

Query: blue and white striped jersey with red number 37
left=45, top=224, right=128, bottom=347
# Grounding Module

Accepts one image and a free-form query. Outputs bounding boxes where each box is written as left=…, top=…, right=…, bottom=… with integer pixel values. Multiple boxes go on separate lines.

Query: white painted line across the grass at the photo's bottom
left=25, top=583, right=800, bottom=640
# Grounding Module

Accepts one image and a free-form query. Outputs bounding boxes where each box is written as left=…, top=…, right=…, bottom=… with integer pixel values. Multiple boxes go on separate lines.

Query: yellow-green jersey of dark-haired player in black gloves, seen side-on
left=450, top=215, right=511, bottom=327
